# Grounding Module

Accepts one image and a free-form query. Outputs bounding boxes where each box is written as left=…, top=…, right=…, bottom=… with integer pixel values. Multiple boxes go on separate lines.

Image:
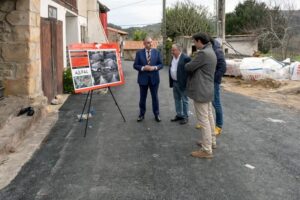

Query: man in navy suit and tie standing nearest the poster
left=133, top=37, right=163, bottom=122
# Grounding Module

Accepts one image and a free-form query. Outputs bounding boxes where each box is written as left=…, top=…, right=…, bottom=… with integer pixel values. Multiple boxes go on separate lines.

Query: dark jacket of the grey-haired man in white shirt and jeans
left=169, top=53, right=191, bottom=90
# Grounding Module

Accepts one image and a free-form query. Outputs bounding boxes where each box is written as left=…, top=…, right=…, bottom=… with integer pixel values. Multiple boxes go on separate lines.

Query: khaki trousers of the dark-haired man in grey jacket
left=194, top=101, right=216, bottom=153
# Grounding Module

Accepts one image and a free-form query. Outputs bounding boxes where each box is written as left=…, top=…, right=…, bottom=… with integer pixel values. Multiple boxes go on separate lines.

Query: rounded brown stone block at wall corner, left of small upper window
left=6, top=11, right=38, bottom=26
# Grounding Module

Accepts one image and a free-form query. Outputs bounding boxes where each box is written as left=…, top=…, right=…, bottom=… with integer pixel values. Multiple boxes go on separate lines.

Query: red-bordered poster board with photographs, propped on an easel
left=68, top=43, right=125, bottom=93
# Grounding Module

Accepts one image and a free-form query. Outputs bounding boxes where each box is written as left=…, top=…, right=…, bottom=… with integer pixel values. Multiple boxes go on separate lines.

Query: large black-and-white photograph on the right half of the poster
left=88, top=50, right=120, bottom=85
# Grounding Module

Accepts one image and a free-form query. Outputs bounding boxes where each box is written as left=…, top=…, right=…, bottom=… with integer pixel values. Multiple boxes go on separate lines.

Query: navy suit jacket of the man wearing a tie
left=133, top=49, right=163, bottom=85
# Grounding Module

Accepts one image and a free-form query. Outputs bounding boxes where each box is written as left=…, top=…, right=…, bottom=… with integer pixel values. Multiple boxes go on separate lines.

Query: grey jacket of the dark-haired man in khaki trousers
left=185, top=43, right=217, bottom=103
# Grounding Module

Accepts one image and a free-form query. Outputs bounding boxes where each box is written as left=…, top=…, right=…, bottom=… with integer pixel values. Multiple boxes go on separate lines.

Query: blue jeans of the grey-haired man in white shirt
left=173, top=81, right=189, bottom=118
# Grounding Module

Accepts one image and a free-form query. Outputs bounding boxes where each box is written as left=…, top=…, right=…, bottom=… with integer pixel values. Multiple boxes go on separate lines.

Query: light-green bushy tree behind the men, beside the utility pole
left=166, top=0, right=213, bottom=39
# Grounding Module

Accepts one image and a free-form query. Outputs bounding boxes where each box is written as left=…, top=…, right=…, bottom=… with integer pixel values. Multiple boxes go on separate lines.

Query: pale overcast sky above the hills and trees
left=100, top=0, right=300, bottom=28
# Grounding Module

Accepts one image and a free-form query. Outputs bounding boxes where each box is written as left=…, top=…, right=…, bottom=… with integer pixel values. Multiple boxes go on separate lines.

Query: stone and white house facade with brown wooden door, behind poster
left=0, top=0, right=108, bottom=101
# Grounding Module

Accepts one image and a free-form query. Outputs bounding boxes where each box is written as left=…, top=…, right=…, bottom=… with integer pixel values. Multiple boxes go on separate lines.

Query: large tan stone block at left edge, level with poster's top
left=2, top=43, right=30, bottom=62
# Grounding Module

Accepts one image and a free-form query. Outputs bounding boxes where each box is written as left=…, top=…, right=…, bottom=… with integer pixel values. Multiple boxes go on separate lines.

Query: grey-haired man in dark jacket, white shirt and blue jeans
left=169, top=44, right=191, bottom=124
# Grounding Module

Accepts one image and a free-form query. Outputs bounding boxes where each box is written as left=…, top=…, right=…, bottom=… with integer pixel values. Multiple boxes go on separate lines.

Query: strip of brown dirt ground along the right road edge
left=222, top=77, right=300, bottom=111
